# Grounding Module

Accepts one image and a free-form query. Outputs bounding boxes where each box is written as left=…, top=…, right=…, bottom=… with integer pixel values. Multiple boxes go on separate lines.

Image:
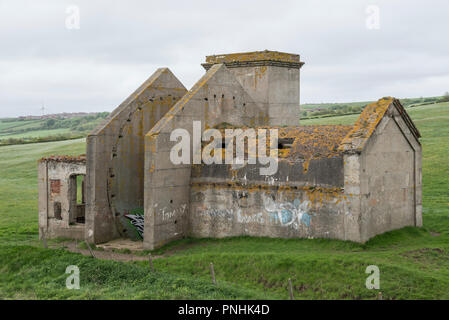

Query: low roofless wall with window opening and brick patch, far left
left=38, top=161, right=86, bottom=239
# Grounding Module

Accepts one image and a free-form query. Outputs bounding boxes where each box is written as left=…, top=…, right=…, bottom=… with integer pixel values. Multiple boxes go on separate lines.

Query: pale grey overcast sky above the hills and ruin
left=0, top=0, right=449, bottom=117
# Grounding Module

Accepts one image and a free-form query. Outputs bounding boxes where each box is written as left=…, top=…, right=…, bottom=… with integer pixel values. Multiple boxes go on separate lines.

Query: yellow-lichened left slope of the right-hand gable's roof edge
left=339, top=97, right=395, bottom=152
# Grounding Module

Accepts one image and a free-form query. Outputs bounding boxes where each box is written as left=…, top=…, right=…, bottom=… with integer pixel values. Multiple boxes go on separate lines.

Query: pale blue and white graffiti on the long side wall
left=263, top=196, right=312, bottom=229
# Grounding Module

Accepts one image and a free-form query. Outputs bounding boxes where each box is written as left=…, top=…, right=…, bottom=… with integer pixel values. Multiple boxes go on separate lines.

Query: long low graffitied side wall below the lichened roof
left=189, top=157, right=359, bottom=241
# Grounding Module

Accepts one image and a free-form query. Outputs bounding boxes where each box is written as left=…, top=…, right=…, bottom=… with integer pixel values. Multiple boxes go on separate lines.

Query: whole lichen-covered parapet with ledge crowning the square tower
left=202, top=50, right=304, bottom=70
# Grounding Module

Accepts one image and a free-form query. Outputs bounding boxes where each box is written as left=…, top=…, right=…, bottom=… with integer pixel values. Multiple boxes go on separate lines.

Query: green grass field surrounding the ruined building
left=0, top=103, right=449, bottom=299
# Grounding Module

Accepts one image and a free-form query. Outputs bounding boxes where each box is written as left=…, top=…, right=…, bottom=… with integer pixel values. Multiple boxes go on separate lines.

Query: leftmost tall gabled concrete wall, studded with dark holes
left=86, top=68, right=187, bottom=243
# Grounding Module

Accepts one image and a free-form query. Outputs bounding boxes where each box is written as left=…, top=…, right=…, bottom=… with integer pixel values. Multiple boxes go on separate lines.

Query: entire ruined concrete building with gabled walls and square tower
left=39, top=51, right=422, bottom=249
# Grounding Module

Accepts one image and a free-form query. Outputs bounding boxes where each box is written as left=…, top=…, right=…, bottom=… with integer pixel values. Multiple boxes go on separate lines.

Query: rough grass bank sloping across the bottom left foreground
left=0, top=246, right=264, bottom=299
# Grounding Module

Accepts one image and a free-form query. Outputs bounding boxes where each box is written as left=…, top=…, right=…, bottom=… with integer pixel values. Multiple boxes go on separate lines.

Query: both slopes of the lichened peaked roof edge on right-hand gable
left=339, top=97, right=421, bottom=153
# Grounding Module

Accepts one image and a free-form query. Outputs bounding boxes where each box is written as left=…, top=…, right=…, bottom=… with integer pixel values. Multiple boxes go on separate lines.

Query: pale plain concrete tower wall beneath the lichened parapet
left=229, top=66, right=300, bottom=126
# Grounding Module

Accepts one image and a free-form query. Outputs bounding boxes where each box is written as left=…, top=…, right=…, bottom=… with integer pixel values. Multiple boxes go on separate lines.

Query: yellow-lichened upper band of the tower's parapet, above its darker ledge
left=206, top=50, right=299, bottom=64
